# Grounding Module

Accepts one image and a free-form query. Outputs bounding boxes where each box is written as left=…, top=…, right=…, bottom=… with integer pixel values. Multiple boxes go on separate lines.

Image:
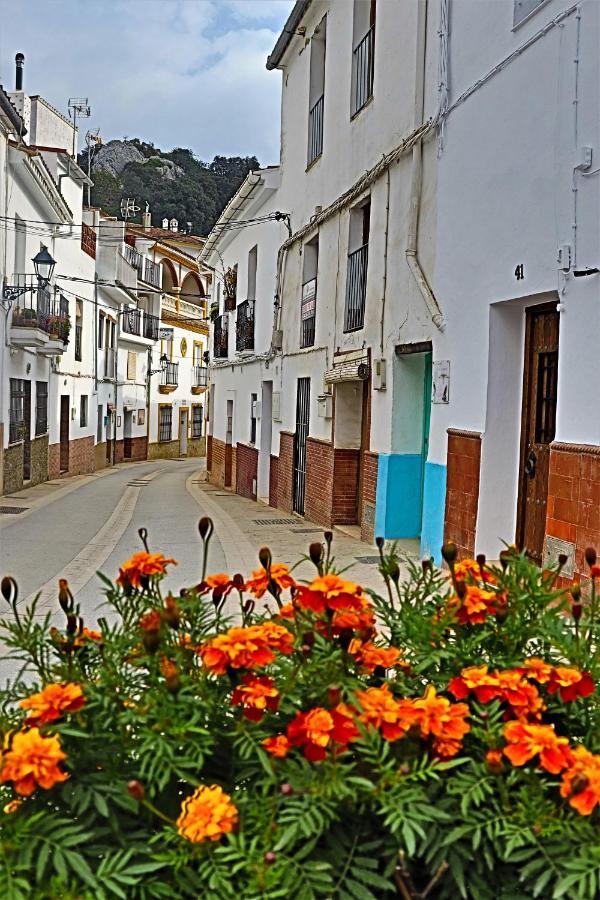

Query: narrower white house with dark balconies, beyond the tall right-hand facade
left=201, top=166, right=287, bottom=500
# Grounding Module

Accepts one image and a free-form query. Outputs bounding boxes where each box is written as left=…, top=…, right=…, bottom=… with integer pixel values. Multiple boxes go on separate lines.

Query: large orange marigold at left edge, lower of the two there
left=0, top=728, right=69, bottom=797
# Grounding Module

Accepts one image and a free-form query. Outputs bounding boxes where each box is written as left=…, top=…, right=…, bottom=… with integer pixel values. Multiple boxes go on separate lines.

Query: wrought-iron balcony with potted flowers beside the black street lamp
left=9, top=275, right=71, bottom=355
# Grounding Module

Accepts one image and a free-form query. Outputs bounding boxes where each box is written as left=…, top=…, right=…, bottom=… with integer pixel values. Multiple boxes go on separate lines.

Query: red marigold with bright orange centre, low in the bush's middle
left=287, top=706, right=359, bottom=762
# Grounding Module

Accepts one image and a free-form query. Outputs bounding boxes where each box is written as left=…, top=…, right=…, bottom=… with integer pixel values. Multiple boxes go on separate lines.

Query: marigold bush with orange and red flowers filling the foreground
left=0, top=520, right=600, bottom=900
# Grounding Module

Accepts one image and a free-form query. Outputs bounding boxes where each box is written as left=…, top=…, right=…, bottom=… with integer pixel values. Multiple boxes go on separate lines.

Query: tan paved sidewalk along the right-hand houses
left=186, top=470, right=418, bottom=593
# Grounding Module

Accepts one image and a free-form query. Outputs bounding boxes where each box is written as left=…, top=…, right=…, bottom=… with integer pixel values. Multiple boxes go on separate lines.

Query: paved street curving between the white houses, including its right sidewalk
left=0, top=459, right=410, bottom=678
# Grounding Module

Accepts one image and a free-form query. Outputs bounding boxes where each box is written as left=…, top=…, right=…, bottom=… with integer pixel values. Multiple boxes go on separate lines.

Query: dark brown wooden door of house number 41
left=517, top=305, right=559, bottom=563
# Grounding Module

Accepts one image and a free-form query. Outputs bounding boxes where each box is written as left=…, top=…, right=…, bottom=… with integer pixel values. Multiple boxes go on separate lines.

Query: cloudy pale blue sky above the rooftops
left=0, top=0, right=293, bottom=165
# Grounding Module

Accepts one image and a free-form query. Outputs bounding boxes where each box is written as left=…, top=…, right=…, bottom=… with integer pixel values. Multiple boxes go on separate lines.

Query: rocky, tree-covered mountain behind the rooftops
left=79, top=138, right=259, bottom=235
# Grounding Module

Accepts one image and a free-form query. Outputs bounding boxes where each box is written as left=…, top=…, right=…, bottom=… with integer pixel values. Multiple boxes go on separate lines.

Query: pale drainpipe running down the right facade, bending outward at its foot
left=405, top=0, right=444, bottom=331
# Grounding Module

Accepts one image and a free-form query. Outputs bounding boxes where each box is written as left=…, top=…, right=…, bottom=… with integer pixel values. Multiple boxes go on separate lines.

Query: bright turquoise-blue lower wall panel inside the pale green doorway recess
left=375, top=453, right=421, bottom=539
